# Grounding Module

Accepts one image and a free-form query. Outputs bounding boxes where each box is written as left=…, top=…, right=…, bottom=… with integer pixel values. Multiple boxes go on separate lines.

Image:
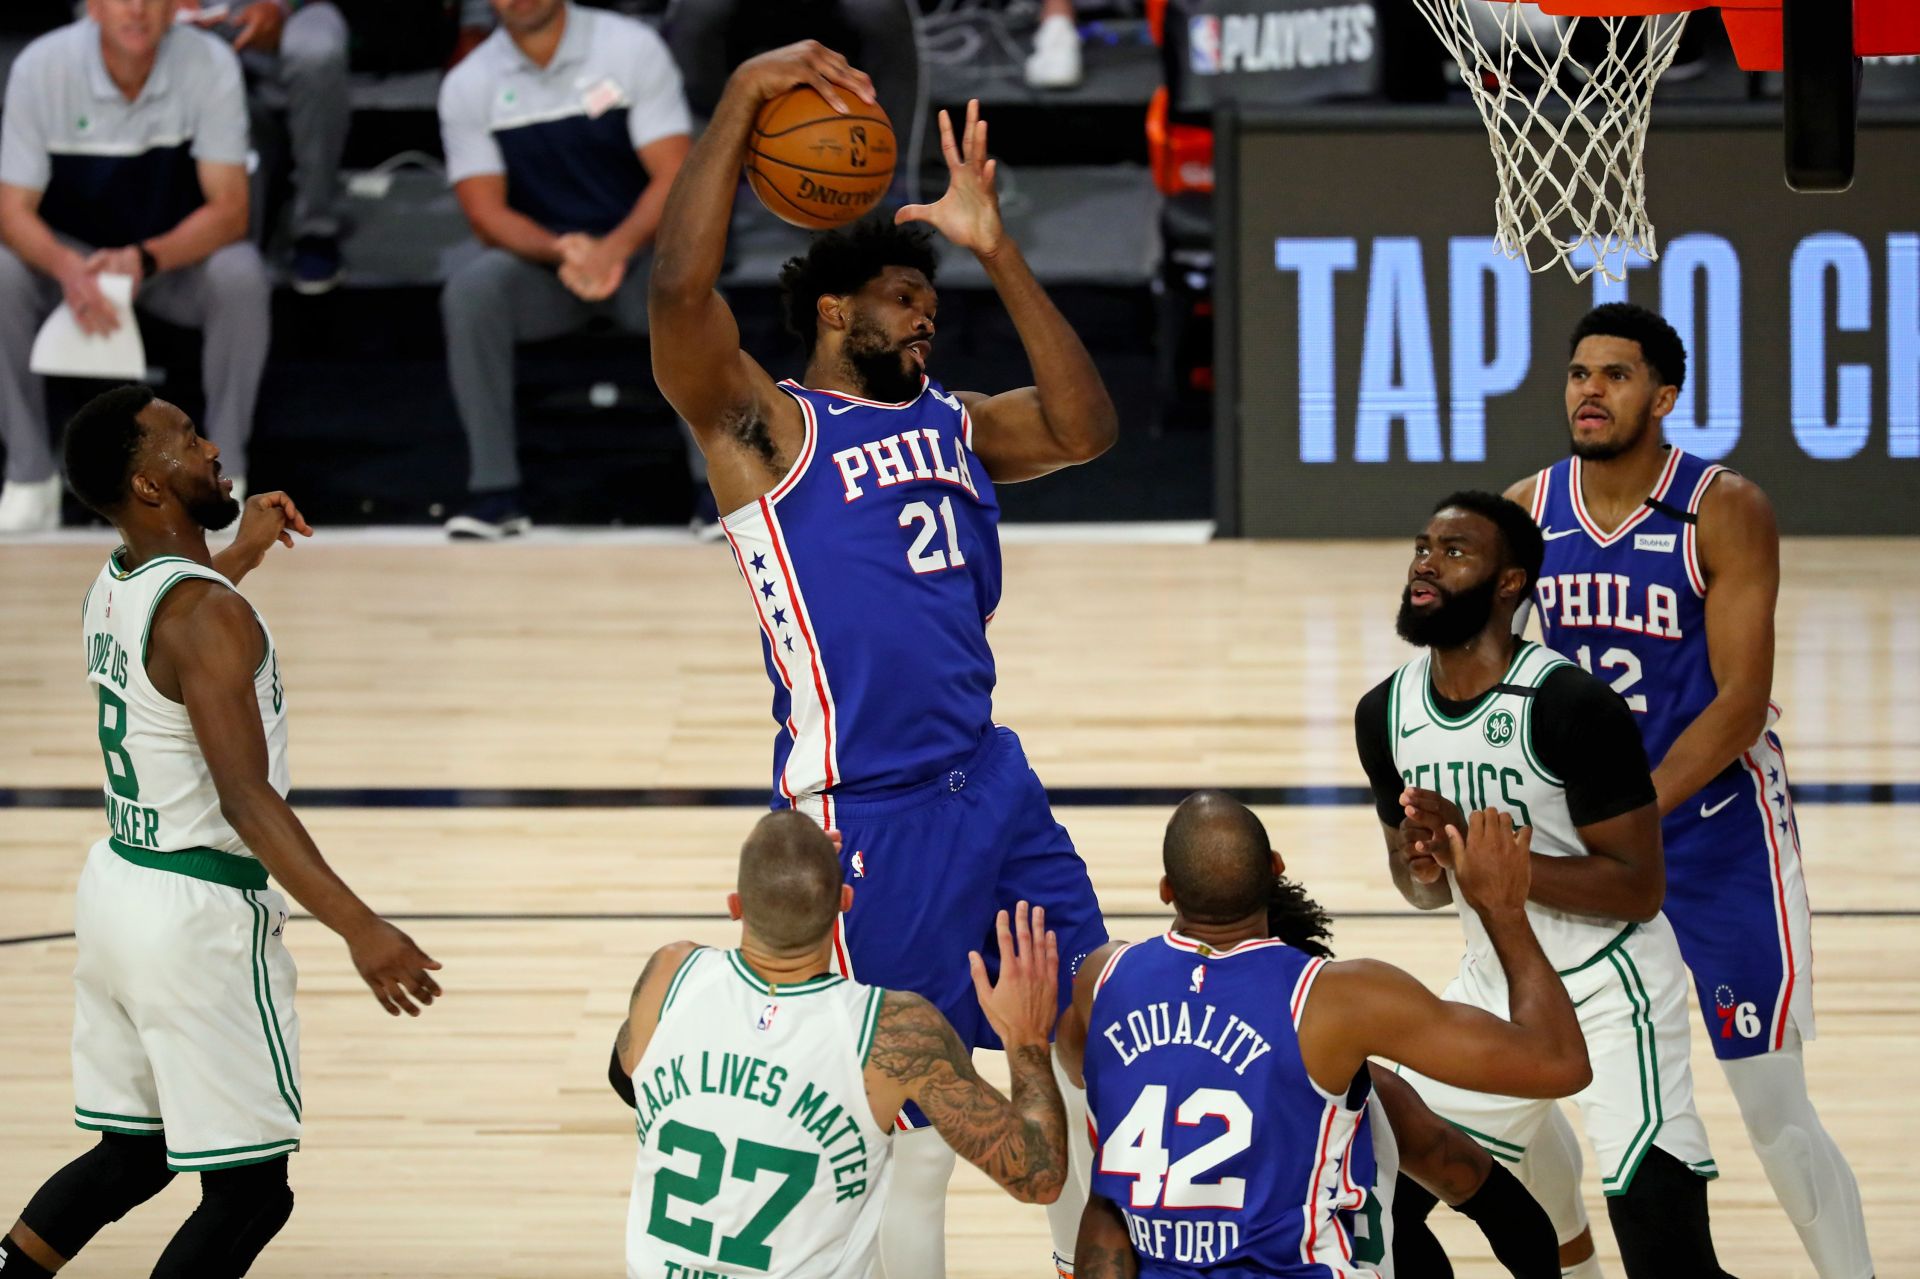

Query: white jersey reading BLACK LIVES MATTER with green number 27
left=626, top=947, right=893, bottom=1279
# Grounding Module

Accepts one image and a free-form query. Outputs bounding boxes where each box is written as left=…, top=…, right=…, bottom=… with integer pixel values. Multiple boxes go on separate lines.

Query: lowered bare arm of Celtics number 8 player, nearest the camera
left=148, top=580, right=440, bottom=1016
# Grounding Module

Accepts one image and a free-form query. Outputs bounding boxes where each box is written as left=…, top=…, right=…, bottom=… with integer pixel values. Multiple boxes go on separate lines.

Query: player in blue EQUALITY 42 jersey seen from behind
left=1062, top=793, right=1592, bottom=1279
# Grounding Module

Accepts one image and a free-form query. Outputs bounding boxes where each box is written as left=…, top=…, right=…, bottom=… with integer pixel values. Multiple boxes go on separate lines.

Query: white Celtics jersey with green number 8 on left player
left=81, top=547, right=288, bottom=860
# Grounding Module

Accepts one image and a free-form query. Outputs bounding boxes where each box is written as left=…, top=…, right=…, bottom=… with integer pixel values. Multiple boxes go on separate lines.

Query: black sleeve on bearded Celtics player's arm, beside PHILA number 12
left=1532, top=666, right=1657, bottom=826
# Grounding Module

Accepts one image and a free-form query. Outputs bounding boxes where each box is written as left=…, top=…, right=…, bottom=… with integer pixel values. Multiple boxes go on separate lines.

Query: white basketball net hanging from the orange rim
left=1413, top=0, right=1686, bottom=280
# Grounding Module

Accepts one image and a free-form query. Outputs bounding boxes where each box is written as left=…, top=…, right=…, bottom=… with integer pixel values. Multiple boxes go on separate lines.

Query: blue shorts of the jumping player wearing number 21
left=803, top=726, right=1108, bottom=1127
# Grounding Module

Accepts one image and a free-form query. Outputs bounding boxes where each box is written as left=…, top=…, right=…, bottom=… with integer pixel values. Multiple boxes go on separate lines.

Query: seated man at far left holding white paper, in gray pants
left=0, top=0, right=269, bottom=532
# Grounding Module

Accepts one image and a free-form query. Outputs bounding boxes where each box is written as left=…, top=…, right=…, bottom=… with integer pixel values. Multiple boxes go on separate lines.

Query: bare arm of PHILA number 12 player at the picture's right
left=1653, top=472, right=1780, bottom=816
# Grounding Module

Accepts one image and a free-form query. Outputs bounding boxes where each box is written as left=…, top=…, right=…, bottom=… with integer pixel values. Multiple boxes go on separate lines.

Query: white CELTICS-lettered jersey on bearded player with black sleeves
left=1386, top=643, right=1630, bottom=971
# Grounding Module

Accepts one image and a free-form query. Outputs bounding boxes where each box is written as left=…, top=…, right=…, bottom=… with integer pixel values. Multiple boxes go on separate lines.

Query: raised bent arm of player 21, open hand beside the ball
left=895, top=102, right=1119, bottom=484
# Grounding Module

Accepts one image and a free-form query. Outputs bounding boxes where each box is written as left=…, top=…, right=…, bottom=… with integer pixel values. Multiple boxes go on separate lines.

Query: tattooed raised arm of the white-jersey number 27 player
left=868, top=903, right=1068, bottom=1204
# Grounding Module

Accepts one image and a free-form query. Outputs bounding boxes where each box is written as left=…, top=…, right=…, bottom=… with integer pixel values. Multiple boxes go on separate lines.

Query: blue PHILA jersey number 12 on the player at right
left=1532, top=447, right=1726, bottom=766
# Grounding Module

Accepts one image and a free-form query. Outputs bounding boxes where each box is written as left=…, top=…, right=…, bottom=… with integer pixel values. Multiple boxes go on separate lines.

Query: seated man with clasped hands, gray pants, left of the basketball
left=440, top=0, right=691, bottom=538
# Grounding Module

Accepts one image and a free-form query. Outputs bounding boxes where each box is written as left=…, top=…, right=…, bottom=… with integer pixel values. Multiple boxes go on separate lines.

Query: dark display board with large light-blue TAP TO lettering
left=1217, top=113, right=1920, bottom=536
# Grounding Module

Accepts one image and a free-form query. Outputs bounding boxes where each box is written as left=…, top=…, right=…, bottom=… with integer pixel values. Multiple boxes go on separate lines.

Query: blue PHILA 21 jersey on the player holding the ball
left=722, top=380, right=1000, bottom=826
